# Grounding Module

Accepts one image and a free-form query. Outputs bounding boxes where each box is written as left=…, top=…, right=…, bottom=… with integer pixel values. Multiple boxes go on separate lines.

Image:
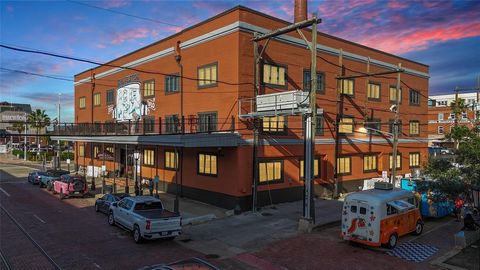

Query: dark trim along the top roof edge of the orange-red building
left=74, top=5, right=429, bottom=77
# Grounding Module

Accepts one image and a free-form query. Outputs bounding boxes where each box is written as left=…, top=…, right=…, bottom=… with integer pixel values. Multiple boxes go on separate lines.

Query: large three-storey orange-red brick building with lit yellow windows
left=53, top=6, right=429, bottom=209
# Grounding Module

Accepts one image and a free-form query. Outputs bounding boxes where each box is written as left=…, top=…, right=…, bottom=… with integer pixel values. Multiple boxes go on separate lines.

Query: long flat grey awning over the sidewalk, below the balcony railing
left=51, top=132, right=241, bottom=147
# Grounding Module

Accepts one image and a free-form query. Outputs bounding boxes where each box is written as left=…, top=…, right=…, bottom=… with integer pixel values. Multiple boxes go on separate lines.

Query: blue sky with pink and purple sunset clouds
left=0, top=0, right=480, bottom=122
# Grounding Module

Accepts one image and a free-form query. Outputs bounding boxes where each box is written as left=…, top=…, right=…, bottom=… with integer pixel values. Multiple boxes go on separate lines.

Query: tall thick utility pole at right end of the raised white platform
left=304, top=13, right=317, bottom=223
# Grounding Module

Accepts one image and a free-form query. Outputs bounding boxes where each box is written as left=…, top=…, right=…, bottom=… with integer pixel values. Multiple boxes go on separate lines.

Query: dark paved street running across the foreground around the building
left=0, top=161, right=461, bottom=269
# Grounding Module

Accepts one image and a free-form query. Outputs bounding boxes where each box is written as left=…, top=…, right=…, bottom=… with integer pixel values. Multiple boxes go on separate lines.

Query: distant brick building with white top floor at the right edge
left=428, top=92, right=479, bottom=147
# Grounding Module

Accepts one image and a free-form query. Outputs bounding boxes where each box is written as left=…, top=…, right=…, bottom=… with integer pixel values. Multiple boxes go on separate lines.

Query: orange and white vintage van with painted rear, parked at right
left=341, top=183, right=423, bottom=248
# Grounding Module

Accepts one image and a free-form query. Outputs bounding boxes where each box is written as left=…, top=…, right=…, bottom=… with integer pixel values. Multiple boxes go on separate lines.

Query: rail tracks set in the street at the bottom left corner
left=0, top=204, right=62, bottom=270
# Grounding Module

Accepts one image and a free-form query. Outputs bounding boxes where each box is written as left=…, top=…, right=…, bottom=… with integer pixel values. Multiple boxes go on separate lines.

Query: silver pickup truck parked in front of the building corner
left=108, top=196, right=182, bottom=243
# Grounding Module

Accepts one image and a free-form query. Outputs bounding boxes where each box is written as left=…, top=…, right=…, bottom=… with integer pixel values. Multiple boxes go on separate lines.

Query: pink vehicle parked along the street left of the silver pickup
left=53, top=174, right=88, bottom=200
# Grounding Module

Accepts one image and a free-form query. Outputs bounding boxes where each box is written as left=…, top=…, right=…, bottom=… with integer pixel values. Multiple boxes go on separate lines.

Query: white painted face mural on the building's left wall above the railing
left=116, top=83, right=142, bottom=121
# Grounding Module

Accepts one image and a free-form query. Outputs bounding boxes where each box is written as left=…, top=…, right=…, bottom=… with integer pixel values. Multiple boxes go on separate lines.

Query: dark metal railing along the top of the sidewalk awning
left=50, top=116, right=235, bottom=136
